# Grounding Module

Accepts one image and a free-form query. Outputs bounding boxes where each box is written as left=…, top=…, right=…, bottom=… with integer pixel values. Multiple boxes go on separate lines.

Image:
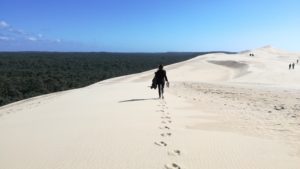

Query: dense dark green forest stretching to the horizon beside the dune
left=0, top=52, right=232, bottom=106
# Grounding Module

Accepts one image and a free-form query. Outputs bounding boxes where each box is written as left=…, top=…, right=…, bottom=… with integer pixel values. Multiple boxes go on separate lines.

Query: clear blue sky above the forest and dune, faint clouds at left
left=0, top=0, right=300, bottom=52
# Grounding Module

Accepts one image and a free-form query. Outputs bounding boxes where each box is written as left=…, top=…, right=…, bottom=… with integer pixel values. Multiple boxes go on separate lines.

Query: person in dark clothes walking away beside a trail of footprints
left=154, top=65, right=169, bottom=99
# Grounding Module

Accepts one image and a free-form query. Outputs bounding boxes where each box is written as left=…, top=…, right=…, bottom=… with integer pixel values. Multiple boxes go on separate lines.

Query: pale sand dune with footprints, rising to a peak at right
left=0, top=47, right=300, bottom=169
